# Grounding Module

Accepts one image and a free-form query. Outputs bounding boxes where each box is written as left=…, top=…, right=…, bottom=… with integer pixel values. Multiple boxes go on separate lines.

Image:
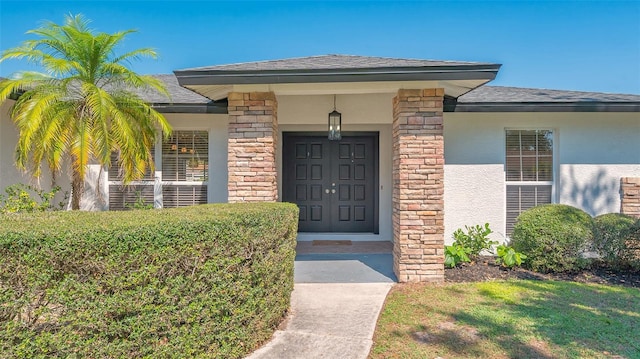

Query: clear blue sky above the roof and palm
left=0, top=0, right=640, bottom=94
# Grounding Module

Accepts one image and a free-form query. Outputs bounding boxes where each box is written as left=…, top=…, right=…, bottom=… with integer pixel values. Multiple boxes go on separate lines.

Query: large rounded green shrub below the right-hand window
left=511, top=204, right=593, bottom=272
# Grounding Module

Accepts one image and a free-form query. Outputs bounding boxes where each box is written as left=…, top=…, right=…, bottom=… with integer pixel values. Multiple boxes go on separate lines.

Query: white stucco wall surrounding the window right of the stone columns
left=444, top=113, right=640, bottom=243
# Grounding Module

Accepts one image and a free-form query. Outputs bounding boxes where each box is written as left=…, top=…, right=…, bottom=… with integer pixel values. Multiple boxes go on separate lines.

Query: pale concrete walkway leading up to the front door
left=248, top=244, right=395, bottom=359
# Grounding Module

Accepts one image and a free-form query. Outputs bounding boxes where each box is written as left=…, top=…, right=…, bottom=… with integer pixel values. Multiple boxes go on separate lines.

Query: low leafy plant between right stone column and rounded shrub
left=444, top=223, right=498, bottom=268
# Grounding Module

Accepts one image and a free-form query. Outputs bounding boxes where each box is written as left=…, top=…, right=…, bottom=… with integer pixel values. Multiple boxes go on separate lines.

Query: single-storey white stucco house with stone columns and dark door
left=0, top=55, right=640, bottom=282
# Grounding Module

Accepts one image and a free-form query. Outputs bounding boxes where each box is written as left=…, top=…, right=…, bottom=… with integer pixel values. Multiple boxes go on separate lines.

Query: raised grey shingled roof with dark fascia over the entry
left=174, top=55, right=501, bottom=88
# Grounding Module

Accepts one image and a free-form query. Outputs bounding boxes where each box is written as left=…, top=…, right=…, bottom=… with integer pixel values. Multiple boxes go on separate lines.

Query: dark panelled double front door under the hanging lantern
left=282, top=133, right=378, bottom=233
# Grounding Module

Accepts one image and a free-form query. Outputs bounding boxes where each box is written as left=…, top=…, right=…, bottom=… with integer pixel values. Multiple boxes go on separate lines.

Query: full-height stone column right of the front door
left=393, top=88, right=444, bottom=282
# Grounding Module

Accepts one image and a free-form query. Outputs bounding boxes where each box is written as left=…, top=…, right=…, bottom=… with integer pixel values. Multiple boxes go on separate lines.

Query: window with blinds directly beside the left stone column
left=162, top=131, right=209, bottom=208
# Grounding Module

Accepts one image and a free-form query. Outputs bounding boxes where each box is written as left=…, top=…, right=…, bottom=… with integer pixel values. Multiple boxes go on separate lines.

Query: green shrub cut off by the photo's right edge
left=593, top=213, right=640, bottom=269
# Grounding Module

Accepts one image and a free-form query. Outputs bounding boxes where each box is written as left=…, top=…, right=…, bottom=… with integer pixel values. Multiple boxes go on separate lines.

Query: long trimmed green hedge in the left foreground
left=0, top=203, right=298, bottom=358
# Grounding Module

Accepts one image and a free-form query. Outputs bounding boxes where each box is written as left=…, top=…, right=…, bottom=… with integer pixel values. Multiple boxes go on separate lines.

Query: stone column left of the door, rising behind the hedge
left=228, top=92, right=278, bottom=203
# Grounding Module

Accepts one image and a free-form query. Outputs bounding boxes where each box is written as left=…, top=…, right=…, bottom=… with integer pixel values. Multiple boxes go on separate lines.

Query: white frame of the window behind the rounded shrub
left=502, top=126, right=559, bottom=238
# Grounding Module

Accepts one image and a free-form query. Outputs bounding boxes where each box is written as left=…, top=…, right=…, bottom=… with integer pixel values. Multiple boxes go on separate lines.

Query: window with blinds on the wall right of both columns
left=505, top=130, right=553, bottom=235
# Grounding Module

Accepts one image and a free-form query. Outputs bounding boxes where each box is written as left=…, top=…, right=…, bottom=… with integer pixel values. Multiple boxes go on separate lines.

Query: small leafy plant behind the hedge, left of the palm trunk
left=0, top=183, right=68, bottom=214
